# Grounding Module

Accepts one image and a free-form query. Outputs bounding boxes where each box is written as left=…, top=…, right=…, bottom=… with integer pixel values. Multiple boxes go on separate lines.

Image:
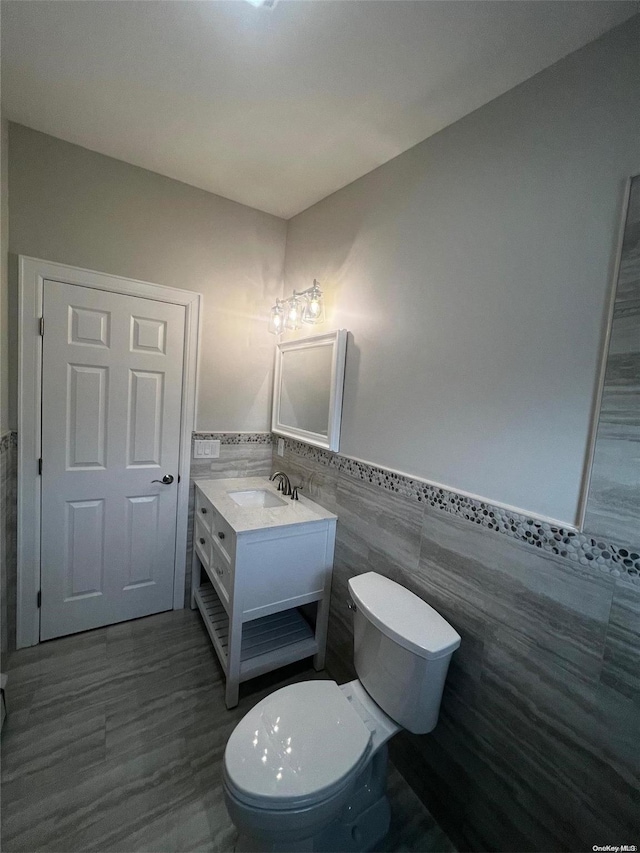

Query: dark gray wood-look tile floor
left=1, top=610, right=454, bottom=853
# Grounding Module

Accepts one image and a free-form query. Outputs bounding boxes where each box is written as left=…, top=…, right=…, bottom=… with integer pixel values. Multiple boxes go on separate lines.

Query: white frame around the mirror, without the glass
left=271, top=329, right=347, bottom=451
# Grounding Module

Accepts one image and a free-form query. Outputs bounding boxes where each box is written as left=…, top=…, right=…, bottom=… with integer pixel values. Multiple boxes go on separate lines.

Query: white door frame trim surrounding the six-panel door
left=16, top=255, right=202, bottom=649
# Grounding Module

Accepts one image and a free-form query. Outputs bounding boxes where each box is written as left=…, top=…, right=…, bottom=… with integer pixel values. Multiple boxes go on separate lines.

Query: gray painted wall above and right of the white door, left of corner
left=9, top=124, right=286, bottom=431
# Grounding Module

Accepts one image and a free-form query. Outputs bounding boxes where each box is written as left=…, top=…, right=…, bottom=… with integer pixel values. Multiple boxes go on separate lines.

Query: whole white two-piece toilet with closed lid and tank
left=224, top=572, right=460, bottom=853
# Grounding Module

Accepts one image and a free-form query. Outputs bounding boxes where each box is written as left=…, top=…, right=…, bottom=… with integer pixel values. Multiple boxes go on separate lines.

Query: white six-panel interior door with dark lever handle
left=40, top=281, right=185, bottom=640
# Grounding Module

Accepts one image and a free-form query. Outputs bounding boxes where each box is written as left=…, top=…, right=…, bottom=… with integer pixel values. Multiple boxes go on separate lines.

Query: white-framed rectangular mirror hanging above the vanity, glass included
left=271, top=329, right=347, bottom=451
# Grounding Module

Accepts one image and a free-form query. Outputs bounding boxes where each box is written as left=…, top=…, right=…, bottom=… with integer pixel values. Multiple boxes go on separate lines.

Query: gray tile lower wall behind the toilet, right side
left=273, top=441, right=640, bottom=851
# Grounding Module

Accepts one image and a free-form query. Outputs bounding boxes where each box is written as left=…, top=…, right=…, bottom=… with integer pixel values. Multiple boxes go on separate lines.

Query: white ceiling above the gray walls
left=2, top=0, right=638, bottom=218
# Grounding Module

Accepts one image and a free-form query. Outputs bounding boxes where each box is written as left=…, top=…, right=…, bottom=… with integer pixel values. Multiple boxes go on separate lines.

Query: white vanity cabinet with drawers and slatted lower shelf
left=191, top=477, right=337, bottom=708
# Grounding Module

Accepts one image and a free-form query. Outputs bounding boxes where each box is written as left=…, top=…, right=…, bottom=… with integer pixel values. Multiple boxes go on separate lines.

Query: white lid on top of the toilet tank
left=349, top=572, right=460, bottom=659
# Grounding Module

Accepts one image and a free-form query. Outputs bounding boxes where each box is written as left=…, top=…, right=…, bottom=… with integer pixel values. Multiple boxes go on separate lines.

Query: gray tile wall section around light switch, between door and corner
left=185, top=432, right=272, bottom=607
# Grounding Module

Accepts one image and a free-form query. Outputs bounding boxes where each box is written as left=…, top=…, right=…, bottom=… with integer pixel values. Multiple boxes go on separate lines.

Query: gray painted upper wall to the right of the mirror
left=285, top=17, right=640, bottom=523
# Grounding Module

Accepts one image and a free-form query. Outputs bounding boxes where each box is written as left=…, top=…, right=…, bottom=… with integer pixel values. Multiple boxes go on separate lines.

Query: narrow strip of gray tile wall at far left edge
left=0, top=432, right=17, bottom=669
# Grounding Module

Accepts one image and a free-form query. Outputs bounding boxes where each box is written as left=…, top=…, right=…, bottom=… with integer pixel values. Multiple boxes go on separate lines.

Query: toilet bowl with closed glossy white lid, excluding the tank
left=224, top=680, right=400, bottom=851
